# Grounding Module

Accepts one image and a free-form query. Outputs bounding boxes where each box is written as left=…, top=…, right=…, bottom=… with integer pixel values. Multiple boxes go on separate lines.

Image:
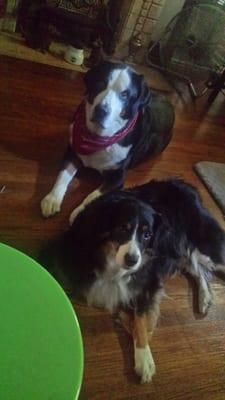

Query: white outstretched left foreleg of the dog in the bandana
left=41, top=163, right=77, bottom=217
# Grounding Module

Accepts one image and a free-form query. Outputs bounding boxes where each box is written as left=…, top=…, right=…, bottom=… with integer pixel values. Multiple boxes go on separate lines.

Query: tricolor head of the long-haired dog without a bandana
left=103, top=199, right=155, bottom=276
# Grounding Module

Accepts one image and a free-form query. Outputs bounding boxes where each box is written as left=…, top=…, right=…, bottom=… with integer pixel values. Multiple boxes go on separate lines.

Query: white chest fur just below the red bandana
left=79, top=143, right=131, bottom=172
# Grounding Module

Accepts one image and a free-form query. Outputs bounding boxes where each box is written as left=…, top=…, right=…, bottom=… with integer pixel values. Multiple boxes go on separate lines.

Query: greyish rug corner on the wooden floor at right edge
left=194, top=161, right=225, bottom=214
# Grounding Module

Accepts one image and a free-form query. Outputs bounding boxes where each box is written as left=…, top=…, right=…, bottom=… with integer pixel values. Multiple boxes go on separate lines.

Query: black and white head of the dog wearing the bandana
left=84, top=61, right=150, bottom=136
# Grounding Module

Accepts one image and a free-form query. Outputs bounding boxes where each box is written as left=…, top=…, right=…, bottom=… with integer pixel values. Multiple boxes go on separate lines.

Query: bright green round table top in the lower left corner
left=0, top=243, right=83, bottom=400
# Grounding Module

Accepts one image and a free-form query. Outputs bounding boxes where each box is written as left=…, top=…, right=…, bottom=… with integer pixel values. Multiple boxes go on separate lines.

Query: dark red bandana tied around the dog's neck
left=71, top=102, right=138, bottom=155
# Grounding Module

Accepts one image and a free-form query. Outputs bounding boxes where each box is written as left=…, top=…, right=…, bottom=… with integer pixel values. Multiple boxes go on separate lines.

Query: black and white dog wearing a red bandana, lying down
left=41, top=62, right=174, bottom=220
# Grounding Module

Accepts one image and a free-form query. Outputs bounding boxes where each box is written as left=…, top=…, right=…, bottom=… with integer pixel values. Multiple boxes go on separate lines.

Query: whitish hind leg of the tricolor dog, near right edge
left=187, top=250, right=213, bottom=314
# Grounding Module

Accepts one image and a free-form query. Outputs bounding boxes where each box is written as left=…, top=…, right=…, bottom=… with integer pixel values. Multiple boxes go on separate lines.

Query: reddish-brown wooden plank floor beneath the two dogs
left=0, top=57, right=225, bottom=400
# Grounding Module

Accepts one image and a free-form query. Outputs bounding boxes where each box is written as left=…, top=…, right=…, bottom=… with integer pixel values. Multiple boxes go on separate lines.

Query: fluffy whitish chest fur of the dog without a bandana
left=87, top=278, right=131, bottom=312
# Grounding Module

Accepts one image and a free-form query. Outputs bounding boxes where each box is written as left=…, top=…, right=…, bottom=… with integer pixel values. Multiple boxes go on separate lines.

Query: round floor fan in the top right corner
left=148, top=0, right=225, bottom=97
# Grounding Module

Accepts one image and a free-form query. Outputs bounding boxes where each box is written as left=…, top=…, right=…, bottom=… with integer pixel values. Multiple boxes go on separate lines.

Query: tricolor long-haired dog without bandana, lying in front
left=45, top=180, right=225, bottom=382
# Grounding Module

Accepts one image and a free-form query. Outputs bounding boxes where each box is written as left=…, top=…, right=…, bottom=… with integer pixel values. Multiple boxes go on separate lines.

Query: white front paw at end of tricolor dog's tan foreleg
left=134, top=346, right=155, bottom=383
